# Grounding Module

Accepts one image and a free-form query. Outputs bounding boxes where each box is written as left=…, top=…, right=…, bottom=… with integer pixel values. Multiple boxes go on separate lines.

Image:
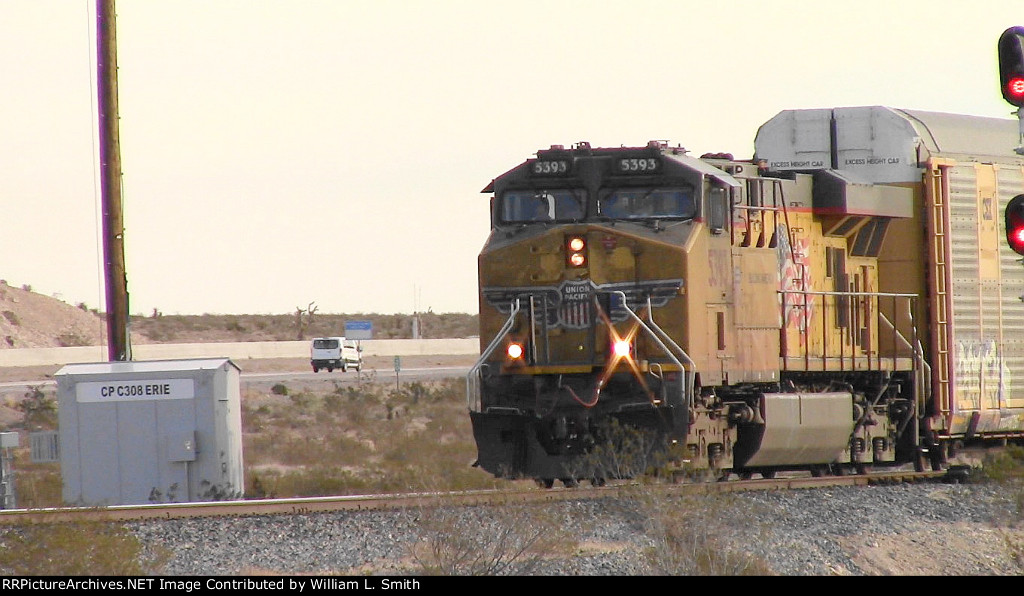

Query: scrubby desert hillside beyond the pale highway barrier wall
left=0, top=280, right=478, bottom=349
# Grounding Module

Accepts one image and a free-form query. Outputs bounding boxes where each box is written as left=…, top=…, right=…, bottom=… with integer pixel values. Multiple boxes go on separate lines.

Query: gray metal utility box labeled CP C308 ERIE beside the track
left=55, top=358, right=244, bottom=506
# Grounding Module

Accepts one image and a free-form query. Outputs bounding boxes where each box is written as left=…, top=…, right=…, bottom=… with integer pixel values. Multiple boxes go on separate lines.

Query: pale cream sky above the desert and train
left=0, top=0, right=1024, bottom=314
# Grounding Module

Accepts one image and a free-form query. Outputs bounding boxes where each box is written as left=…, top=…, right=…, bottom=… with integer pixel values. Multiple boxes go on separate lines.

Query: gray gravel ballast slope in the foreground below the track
left=129, top=483, right=1024, bottom=576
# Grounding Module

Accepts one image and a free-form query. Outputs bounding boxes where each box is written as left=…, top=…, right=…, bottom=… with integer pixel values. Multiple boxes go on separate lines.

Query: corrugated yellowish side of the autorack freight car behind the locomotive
left=928, top=158, right=1024, bottom=437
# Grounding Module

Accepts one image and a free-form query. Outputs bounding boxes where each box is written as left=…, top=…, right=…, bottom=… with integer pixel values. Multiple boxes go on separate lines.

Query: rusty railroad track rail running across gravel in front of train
left=0, top=467, right=950, bottom=525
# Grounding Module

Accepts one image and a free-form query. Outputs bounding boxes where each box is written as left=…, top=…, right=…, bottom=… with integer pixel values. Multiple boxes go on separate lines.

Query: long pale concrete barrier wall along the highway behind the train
left=0, top=337, right=480, bottom=368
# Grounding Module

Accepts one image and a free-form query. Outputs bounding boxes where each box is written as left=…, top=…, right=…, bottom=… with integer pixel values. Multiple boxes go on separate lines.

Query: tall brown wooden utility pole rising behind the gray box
left=96, top=0, right=131, bottom=361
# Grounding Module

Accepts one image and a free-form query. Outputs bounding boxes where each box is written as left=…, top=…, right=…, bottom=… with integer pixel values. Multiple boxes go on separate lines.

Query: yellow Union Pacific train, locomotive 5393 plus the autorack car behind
left=467, top=107, right=1024, bottom=486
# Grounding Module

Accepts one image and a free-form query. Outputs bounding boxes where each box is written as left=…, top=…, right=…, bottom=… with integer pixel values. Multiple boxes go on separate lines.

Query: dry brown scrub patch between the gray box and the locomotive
left=236, top=374, right=507, bottom=498
